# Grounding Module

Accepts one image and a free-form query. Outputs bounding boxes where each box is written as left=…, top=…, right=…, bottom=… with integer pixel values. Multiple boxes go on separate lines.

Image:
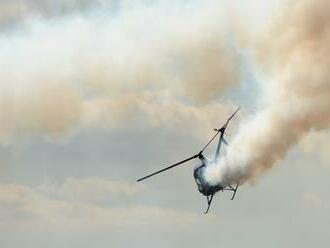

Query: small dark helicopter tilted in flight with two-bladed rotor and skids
left=137, top=107, right=240, bottom=214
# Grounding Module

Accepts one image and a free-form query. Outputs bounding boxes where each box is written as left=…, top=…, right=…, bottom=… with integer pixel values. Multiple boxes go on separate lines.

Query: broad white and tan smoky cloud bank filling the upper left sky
left=0, top=1, right=240, bottom=141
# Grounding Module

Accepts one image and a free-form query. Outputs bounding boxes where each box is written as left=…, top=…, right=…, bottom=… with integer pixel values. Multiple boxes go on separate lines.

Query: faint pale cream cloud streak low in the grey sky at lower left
left=0, top=178, right=211, bottom=231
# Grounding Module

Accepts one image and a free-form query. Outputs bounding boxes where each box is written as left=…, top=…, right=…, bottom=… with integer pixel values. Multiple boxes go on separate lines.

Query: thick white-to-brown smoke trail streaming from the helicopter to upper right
left=208, top=0, right=330, bottom=186
